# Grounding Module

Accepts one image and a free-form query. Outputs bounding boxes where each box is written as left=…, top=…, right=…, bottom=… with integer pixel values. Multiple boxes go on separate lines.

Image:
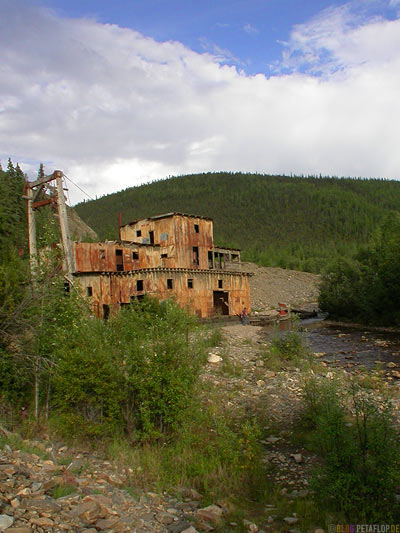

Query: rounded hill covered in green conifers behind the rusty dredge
left=76, top=172, right=400, bottom=272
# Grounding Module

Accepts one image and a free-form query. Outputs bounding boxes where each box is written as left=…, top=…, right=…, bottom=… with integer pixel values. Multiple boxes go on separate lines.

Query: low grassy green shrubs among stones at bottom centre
left=110, top=391, right=267, bottom=505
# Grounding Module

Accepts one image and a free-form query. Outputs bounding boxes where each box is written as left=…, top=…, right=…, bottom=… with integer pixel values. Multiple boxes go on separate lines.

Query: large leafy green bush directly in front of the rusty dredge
left=52, top=299, right=203, bottom=440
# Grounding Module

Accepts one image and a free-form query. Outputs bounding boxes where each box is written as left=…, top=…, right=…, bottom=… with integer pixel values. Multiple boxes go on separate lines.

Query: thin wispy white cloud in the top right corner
left=276, top=0, right=400, bottom=75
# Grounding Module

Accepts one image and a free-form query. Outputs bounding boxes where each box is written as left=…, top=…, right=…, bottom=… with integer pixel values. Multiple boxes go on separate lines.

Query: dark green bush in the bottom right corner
left=305, top=378, right=400, bottom=523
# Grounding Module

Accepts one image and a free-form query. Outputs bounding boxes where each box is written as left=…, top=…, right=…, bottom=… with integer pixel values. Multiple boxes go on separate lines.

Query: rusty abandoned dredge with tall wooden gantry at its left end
left=26, top=171, right=250, bottom=318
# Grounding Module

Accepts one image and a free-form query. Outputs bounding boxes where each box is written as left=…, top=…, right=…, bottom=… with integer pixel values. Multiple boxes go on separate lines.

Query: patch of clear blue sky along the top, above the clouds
left=38, top=0, right=398, bottom=76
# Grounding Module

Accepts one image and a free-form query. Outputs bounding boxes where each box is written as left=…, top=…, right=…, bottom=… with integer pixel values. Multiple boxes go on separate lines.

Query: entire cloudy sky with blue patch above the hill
left=0, top=0, right=400, bottom=204
